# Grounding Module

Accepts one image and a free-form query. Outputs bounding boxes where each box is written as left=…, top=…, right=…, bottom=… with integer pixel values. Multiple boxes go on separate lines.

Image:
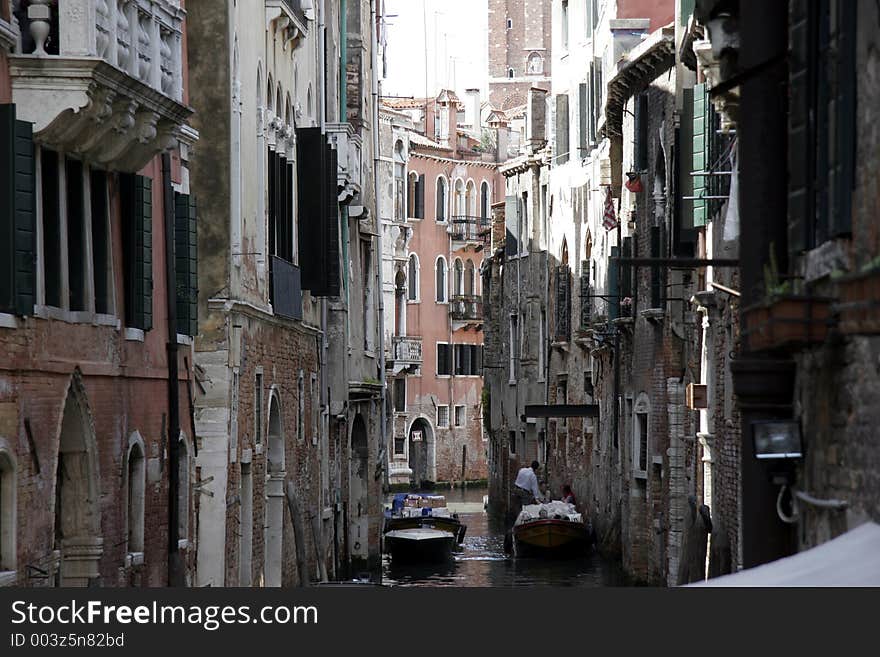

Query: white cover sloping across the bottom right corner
left=689, top=522, right=880, bottom=586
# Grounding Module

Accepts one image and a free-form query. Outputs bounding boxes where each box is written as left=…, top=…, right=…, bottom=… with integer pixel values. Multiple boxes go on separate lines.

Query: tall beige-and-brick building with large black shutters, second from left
left=188, top=1, right=384, bottom=586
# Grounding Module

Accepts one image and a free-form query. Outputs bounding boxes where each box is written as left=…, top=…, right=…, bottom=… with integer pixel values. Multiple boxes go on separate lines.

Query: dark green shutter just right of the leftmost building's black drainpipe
left=174, top=194, right=199, bottom=335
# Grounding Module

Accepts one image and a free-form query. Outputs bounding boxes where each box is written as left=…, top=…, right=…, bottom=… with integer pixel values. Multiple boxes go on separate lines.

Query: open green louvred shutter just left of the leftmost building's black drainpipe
left=119, top=174, right=153, bottom=331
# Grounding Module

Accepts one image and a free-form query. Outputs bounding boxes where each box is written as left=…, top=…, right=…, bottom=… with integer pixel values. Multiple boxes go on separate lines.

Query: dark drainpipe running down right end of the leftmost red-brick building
left=162, top=153, right=186, bottom=586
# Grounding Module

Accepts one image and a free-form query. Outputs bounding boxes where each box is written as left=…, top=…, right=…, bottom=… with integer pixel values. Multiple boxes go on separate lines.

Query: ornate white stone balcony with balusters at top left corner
left=10, top=0, right=192, bottom=171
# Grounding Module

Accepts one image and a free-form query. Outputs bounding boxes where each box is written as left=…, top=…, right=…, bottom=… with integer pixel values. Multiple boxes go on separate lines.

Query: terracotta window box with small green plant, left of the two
left=743, top=245, right=831, bottom=351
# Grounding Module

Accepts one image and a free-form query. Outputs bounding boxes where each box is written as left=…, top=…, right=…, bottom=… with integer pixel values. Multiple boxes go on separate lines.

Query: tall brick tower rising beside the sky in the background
left=488, top=0, right=552, bottom=111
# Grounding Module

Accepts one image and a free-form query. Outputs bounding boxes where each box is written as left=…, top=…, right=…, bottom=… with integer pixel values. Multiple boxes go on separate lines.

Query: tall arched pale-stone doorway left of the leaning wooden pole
left=263, top=391, right=287, bottom=586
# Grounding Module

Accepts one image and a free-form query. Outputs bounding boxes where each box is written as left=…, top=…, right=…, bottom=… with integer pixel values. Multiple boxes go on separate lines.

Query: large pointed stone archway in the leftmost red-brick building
left=55, top=374, right=104, bottom=587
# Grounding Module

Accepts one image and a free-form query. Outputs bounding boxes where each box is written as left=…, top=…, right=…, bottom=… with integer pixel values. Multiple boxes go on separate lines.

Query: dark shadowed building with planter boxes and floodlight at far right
left=693, top=1, right=880, bottom=568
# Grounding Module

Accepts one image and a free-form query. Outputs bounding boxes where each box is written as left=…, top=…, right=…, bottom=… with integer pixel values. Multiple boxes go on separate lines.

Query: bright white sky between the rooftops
left=382, top=0, right=488, bottom=98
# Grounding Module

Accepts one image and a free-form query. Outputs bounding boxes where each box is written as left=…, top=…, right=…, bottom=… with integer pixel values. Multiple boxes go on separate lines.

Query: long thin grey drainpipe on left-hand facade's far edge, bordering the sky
left=370, top=0, right=388, bottom=584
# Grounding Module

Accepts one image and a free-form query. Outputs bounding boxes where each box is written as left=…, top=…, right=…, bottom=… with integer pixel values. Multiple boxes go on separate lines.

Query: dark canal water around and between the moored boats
left=383, top=488, right=624, bottom=587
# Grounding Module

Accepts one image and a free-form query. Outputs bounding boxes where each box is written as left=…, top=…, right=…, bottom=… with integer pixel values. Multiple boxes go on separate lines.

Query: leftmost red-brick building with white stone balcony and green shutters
left=0, top=0, right=198, bottom=586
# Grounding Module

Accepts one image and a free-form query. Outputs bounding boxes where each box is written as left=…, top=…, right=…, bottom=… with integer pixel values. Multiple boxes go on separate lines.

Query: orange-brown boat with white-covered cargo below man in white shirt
left=512, top=501, right=593, bottom=558
